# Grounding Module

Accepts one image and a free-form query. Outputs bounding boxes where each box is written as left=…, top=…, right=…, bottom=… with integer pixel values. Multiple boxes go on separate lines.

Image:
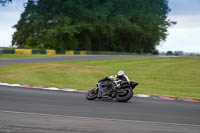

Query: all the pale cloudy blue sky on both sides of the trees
left=0, top=0, right=200, bottom=53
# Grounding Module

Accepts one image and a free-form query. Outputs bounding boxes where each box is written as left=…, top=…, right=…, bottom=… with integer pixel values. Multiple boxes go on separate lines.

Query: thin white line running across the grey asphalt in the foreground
left=0, top=110, right=200, bottom=127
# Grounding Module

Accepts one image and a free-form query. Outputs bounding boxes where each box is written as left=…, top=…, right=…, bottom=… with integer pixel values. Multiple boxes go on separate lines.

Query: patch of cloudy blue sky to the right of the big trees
left=157, top=0, right=200, bottom=53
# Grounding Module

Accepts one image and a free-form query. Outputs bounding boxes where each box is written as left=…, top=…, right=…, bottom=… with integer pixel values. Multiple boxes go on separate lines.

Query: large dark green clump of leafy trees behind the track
left=12, top=0, right=174, bottom=53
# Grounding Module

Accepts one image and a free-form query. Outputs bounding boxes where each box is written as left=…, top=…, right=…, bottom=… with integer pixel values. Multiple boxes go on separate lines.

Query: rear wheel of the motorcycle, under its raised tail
left=116, top=88, right=133, bottom=102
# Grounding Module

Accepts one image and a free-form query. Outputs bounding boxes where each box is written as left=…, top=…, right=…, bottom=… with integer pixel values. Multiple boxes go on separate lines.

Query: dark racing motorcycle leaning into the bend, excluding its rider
left=86, top=77, right=138, bottom=102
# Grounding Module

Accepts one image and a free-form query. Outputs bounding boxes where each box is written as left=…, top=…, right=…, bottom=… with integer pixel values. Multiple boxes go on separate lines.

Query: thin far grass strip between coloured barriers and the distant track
left=0, top=54, right=65, bottom=60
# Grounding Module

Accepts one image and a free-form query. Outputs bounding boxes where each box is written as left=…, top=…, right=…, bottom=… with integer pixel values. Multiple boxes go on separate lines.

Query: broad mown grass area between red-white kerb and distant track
left=0, top=57, right=200, bottom=100
